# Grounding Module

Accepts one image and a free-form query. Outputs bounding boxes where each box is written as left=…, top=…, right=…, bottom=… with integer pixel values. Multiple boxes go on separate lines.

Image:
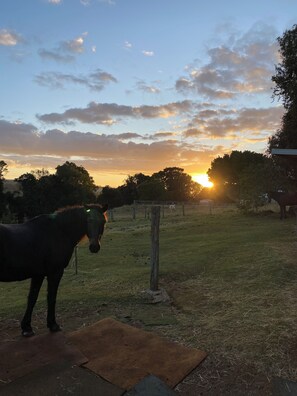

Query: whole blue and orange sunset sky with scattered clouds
left=0, top=0, right=297, bottom=187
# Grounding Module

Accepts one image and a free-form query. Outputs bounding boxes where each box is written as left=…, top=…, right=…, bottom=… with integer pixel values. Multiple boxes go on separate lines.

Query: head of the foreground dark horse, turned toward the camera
left=85, top=205, right=108, bottom=253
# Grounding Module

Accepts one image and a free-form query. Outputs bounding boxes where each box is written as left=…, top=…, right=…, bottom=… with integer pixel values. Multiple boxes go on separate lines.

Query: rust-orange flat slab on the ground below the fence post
left=67, top=318, right=206, bottom=390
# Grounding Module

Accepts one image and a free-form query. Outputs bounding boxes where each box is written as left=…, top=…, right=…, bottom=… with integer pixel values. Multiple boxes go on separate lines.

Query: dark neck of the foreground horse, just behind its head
left=55, top=208, right=87, bottom=245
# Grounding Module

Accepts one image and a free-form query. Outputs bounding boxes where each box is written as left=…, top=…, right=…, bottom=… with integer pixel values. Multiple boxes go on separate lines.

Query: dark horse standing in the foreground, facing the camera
left=0, top=204, right=107, bottom=337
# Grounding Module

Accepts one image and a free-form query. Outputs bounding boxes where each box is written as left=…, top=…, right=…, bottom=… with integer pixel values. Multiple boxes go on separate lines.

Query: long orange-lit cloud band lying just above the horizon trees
left=0, top=120, right=221, bottom=179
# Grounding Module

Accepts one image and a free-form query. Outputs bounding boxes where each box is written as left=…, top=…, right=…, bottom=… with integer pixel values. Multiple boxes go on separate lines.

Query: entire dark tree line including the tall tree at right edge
left=0, top=25, right=297, bottom=221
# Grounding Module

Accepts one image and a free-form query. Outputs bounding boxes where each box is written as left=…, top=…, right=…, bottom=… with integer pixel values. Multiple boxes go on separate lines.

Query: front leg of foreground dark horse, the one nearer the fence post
left=47, top=269, right=64, bottom=332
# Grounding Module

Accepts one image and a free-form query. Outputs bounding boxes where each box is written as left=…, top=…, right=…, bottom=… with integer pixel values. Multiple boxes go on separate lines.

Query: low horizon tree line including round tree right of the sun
left=0, top=151, right=287, bottom=222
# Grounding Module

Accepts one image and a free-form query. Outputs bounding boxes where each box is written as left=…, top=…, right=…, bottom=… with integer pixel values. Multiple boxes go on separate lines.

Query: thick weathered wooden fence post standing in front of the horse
left=150, top=206, right=161, bottom=291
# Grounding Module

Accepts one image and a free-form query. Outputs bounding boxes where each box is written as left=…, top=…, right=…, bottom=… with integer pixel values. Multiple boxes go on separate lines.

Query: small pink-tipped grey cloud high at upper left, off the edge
left=38, top=33, right=87, bottom=63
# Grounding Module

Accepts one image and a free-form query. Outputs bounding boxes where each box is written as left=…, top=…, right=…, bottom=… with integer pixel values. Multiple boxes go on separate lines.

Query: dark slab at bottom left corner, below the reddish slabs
left=0, top=362, right=123, bottom=396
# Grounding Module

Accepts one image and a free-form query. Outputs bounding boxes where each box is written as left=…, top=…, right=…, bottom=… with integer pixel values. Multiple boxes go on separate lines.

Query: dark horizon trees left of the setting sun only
left=0, top=161, right=201, bottom=222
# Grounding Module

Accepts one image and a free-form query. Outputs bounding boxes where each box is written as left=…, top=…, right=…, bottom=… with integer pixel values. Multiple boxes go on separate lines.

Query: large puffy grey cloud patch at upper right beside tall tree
left=175, top=23, right=278, bottom=100
